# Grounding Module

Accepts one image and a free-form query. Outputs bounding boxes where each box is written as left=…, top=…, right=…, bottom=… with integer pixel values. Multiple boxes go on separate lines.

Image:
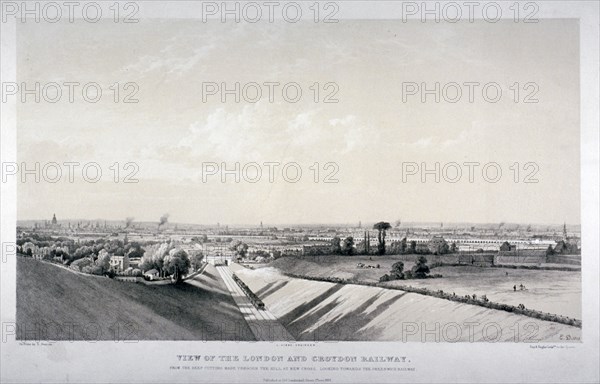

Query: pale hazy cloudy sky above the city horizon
left=17, top=19, right=580, bottom=225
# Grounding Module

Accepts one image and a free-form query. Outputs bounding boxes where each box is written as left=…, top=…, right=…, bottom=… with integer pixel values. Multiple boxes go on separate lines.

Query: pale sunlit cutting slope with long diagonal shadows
left=232, top=266, right=581, bottom=343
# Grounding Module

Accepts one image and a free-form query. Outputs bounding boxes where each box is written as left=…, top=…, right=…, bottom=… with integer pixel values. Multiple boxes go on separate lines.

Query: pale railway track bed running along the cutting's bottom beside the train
left=217, top=266, right=294, bottom=341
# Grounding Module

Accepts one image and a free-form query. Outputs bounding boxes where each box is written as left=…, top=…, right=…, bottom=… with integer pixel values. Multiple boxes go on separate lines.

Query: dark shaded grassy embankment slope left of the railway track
left=17, top=257, right=254, bottom=341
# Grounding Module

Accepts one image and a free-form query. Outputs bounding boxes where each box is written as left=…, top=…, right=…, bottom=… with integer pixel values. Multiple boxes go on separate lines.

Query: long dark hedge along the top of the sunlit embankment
left=284, top=273, right=581, bottom=328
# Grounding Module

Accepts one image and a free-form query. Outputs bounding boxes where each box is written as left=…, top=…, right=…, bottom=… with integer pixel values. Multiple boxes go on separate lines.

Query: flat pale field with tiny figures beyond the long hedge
left=269, top=256, right=581, bottom=319
